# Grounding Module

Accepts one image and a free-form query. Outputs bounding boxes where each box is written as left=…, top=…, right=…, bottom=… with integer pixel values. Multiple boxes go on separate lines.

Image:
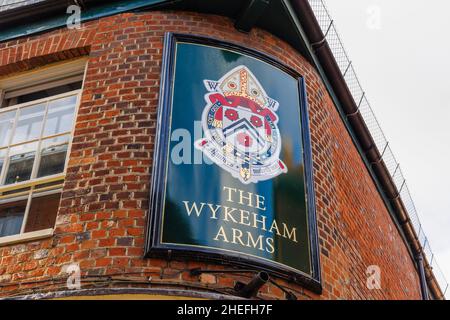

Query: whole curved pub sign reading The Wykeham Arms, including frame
left=146, top=33, right=320, bottom=290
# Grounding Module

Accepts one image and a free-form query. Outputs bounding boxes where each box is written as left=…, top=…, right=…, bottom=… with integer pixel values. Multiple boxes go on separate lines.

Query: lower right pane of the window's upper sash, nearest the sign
left=37, top=135, right=70, bottom=178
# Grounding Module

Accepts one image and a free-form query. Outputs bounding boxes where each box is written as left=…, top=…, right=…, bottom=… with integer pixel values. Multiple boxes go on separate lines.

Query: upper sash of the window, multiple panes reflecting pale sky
left=0, top=95, right=77, bottom=185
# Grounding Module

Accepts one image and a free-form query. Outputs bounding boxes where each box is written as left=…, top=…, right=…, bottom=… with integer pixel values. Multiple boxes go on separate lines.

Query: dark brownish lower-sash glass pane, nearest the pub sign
left=25, top=193, right=61, bottom=232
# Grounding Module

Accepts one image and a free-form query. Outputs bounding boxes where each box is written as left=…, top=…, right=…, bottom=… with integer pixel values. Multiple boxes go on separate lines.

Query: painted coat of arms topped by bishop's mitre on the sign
left=195, top=65, right=287, bottom=184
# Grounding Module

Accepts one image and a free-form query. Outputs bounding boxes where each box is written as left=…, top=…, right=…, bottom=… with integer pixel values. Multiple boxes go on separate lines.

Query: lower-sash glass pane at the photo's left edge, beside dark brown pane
left=0, top=200, right=27, bottom=237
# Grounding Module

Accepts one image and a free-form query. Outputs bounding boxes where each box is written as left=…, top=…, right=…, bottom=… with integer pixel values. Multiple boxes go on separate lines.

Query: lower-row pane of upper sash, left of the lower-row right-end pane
left=5, top=142, right=37, bottom=184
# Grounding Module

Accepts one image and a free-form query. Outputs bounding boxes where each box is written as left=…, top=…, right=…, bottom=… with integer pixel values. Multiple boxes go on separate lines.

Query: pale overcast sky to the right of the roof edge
left=325, top=0, right=450, bottom=298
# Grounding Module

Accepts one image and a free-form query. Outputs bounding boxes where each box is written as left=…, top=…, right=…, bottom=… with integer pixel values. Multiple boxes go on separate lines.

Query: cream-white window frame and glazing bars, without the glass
left=0, top=58, right=87, bottom=242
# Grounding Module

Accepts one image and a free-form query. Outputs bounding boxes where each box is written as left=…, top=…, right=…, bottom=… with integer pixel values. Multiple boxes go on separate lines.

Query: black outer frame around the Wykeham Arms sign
left=145, top=32, right=322, bottom=293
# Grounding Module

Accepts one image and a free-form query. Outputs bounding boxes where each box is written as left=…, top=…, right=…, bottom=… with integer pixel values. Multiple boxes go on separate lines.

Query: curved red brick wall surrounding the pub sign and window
left=0, top=12, right=420, bottom=299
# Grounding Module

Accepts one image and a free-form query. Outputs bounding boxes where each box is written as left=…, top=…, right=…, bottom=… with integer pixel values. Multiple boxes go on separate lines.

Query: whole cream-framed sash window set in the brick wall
left=0, top=60, right=85, bottom=243
